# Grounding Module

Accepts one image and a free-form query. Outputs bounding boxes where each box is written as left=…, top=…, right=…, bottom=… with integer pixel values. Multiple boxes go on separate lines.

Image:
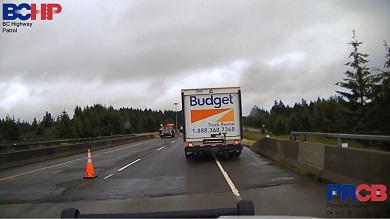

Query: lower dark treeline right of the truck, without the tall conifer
left=243, top=96, right=376, bottom=135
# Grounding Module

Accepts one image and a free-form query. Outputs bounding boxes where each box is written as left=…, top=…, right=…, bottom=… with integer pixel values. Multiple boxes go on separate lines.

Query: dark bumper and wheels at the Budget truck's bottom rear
left=184, top=145, right=243, bottom=156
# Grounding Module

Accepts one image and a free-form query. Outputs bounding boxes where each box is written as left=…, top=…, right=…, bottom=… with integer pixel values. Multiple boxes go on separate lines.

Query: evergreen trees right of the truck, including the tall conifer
left=244, top=31, right=390, bottom=135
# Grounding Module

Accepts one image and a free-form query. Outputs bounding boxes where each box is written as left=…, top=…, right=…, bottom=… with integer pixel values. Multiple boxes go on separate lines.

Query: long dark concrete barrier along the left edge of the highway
left=0, top=134, right=155, bottom=169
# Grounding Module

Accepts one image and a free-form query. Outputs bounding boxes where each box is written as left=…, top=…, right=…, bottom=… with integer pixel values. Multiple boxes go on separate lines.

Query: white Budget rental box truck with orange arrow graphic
left=181, top=87, right=243, bottom=158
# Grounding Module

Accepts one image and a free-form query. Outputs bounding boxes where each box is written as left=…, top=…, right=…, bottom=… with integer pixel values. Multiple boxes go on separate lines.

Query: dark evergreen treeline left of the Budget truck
left=0, top=104, right=181, bottom=143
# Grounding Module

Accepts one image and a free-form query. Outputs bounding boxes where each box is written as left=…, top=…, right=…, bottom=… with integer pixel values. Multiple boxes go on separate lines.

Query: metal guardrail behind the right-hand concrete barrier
left=290, top=132, right=390, bottom=147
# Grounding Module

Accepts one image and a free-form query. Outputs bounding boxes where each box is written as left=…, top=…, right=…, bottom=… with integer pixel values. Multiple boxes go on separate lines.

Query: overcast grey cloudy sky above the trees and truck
left=0, top=0, right=390, bottom=123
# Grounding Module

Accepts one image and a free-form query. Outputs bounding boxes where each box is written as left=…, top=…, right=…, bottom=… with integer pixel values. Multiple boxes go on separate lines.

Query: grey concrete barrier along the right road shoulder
left=251, top=138, right=390, bottom=188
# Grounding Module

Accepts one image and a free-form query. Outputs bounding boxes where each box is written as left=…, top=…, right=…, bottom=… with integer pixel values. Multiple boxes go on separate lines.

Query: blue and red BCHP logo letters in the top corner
left=3, top=3, right=62, bottom=21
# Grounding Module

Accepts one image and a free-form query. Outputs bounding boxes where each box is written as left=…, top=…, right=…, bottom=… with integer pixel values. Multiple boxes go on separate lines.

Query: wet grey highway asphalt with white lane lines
left=0, top=138, right=390, bottom=218
